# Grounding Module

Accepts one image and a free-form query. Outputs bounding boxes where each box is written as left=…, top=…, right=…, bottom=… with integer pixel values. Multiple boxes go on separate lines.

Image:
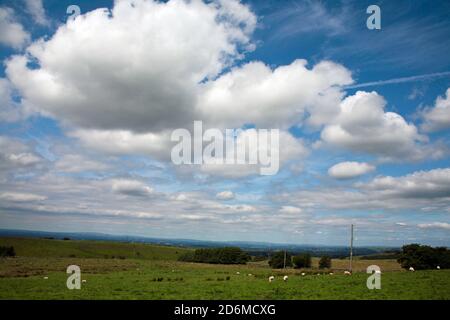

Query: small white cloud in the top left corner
left=0, top=7, right=31, bottom=49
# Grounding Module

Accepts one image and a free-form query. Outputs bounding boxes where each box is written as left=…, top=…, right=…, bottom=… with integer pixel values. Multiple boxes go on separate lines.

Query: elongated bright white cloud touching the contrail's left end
left=198, top=60, right=353, bottom=129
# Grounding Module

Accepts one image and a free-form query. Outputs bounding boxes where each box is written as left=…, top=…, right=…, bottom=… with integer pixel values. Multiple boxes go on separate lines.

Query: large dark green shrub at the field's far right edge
left=397, top=243, right=450, bottom=270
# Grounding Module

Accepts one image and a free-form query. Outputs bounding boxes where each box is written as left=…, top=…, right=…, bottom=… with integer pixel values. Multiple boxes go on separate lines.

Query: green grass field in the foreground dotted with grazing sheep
left=0, top=238, right=450, bottom=299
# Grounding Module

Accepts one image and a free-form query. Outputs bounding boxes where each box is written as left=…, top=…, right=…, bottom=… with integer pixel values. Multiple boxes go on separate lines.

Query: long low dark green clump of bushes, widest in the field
left=178, top=247, right=250, bottom=264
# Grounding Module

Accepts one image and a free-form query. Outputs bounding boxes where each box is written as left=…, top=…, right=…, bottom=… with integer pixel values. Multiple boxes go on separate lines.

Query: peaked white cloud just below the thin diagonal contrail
left=321, top=91, right=426, bottom=160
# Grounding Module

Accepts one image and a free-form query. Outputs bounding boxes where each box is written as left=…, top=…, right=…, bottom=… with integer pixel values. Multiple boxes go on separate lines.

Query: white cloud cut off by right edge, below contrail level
left=422, top=88, right=450, bottom=131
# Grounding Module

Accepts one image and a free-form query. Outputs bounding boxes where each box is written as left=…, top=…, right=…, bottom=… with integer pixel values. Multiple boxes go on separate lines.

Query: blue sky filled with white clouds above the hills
left=0, top=0, right=450, bottom=246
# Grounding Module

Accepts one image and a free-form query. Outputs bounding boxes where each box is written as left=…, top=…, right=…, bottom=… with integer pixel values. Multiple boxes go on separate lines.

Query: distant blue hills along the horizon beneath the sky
left=0, top=229, right=397, bottom=258
